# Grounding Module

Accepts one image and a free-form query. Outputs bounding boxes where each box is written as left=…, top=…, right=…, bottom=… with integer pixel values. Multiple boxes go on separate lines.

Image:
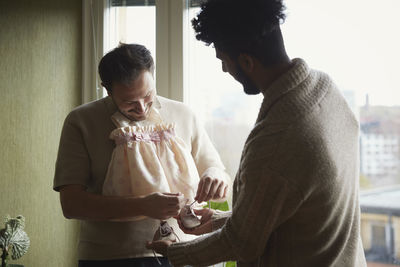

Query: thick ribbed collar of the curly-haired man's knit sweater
left=257, top=58, right=330, bottom=123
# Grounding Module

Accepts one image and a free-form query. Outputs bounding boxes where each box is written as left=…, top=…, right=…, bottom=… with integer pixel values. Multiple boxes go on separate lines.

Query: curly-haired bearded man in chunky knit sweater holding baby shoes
left=147, top=0, right=366, bottom=267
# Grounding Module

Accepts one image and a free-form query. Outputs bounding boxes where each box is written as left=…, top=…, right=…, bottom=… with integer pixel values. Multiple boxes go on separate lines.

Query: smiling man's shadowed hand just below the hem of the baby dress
left=143, top=192, right=187, bottom=220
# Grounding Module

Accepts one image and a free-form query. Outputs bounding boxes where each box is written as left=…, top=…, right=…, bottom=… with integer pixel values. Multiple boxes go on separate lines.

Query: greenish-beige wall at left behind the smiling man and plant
left=0, top=0, right=82, bottom=267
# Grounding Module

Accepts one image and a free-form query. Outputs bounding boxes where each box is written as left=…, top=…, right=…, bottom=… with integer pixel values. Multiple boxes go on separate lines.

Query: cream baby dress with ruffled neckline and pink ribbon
left=103, top=104, right=199, bottom=220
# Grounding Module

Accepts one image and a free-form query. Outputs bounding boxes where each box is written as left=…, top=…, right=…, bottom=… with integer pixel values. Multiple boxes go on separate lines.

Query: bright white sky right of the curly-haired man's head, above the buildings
left=282, top=0, right=400, bottom=106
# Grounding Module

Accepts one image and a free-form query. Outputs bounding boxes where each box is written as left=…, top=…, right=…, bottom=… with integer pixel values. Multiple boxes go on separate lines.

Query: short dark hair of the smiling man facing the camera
left=98, top=43, right=154, bottom=91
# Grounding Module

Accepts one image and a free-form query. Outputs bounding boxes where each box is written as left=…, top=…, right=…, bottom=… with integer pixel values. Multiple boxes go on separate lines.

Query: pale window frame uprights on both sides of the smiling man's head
left=82, top=0, right=189, bottom=103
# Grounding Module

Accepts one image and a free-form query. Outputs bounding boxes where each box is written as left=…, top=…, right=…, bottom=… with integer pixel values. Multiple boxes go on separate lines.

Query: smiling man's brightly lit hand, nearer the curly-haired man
left=194, top=175, right=228, bottom=203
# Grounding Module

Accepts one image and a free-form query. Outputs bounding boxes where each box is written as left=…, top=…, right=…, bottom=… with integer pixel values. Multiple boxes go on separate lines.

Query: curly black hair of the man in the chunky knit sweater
left=192, top=0, right=286, bottom=66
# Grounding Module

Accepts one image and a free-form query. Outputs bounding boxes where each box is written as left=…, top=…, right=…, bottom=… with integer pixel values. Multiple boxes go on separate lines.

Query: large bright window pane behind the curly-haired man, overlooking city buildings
left=185, top=0, right=400, bottom=266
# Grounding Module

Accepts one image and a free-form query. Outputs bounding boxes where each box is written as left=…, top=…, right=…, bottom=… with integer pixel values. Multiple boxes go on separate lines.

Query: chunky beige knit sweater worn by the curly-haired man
left=168, top=59, right=366, bottom=267
